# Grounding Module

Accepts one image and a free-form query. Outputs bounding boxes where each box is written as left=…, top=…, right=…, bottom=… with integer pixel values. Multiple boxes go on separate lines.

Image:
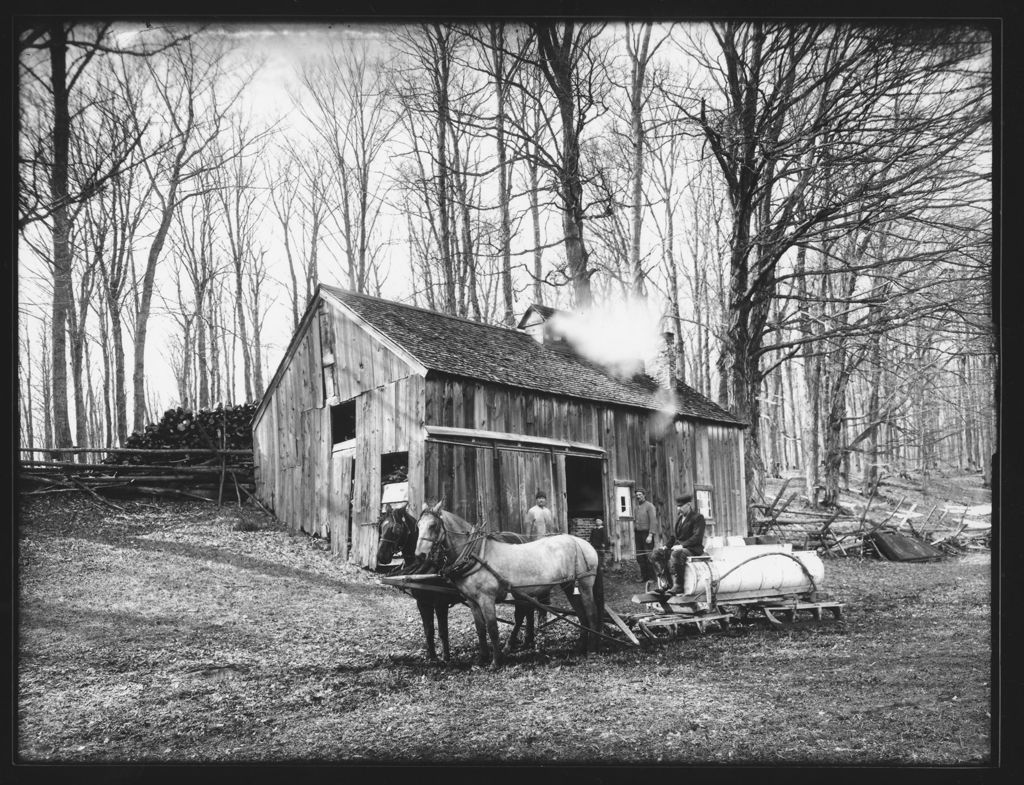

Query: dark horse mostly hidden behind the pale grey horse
left=377, top=508, right=550, bottom=662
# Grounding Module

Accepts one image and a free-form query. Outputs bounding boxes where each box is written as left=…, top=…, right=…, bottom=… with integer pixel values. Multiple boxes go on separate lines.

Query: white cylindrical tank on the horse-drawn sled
left=683, top=544, right=825, bottom=603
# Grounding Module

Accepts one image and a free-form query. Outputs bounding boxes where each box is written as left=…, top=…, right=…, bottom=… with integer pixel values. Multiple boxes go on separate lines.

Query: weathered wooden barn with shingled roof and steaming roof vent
left=247, top=285, right=748, bottom=566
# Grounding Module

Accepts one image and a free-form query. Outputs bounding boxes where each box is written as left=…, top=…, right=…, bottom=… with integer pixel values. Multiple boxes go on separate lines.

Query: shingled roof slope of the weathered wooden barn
left=319, top=284, right=743, bottom=425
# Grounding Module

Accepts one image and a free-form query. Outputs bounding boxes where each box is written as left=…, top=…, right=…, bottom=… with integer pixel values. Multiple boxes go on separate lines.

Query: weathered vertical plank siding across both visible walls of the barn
left=253, top=309, right=746, bottom=565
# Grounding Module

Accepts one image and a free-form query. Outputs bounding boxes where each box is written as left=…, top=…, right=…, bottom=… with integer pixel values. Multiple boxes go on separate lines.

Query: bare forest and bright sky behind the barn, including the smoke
left=17, top=18, right=997, bottom=503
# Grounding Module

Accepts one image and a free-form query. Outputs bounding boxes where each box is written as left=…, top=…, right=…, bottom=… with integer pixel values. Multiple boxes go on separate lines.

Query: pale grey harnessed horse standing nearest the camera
left=416, top=501, right=601, bottom=669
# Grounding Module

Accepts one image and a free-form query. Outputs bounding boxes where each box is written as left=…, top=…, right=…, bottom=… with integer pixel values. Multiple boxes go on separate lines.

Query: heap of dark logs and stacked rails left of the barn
left=19, top=404, right=255, bottom=507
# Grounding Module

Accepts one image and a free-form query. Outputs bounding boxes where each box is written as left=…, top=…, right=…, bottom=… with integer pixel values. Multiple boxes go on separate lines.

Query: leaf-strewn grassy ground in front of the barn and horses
left=16, top=497, right=991, bottom=766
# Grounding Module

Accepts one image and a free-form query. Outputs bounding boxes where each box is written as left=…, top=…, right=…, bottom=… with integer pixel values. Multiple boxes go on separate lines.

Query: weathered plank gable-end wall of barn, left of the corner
left=253, top=300, right=423, bottom=565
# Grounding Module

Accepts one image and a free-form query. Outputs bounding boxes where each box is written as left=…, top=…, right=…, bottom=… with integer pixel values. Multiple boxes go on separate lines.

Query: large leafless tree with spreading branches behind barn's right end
left=667, top=21, right=986, bottom=507
